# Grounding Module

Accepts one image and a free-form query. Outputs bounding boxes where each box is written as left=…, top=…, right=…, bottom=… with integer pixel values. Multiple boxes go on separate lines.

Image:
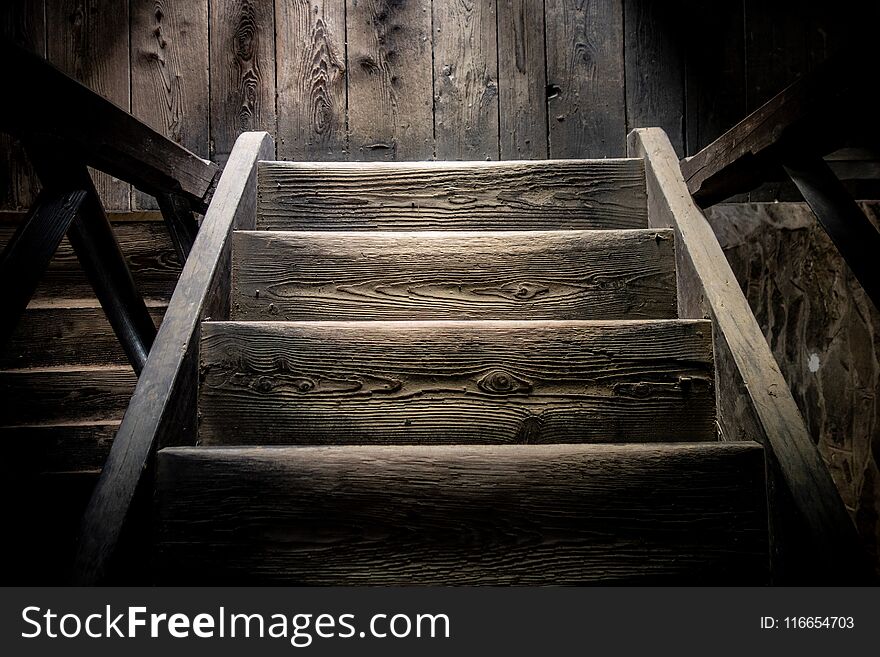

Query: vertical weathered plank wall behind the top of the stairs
left=0, top=0, right=868, bottom=211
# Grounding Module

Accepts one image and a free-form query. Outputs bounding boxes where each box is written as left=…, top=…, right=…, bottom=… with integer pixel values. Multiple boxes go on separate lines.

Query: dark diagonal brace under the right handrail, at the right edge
left=784, top=155, right=880, bottom=309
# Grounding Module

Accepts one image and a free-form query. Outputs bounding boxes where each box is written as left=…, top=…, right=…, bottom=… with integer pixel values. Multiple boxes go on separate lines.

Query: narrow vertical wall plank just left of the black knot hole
left=498, top=0, right=547, bottom=160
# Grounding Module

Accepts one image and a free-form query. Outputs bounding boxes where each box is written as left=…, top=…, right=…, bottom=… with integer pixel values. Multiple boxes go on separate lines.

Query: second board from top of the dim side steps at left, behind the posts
left=0, top=299, right=166, bottom=369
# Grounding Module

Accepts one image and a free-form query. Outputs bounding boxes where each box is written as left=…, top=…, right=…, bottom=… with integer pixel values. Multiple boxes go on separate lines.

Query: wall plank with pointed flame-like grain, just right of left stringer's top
left=275, top=0, right=348, bottom=161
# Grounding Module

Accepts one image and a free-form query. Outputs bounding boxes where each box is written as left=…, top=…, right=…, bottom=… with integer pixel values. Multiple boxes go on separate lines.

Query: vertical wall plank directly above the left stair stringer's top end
left=209, top=0, right=276, bottom=163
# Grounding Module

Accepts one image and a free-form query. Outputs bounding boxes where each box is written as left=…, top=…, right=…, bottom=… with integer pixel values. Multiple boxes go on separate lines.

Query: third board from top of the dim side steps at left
left=0, top=365, right=137, bottom=426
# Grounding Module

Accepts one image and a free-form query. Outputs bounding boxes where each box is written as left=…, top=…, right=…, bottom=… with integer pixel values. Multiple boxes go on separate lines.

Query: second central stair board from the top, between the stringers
left=232, top=230, right=677, bottom=320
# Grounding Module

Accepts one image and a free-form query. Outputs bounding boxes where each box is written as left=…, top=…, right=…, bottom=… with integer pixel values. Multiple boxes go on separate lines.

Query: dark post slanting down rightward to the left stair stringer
left=27, top=146, right=156, bottom=375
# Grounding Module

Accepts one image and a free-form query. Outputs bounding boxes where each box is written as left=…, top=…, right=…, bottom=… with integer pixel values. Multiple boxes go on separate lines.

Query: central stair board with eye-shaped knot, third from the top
left=199, top=320, right=716, bottom=445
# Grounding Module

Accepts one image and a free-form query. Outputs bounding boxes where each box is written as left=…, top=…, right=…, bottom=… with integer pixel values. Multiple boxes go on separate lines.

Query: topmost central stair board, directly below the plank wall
left=257, top=159, right=648, bottom=231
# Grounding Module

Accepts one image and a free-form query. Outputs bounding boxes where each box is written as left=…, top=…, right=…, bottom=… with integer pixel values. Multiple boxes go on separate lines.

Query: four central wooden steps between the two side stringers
left=156, top=159, right=769, bottom=585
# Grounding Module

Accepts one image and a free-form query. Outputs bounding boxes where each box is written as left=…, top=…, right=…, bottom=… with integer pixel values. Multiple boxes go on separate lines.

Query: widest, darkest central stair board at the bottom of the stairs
left=157, top=443, right=769, bottom=585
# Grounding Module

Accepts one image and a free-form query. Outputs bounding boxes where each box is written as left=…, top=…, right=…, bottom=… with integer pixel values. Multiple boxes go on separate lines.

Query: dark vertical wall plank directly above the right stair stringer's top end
left=624, top=0, right=692, bottom=156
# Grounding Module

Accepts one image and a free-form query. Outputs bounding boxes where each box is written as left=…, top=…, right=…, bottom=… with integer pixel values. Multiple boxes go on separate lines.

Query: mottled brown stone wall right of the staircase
left=706, top=203, right=880, bottom=571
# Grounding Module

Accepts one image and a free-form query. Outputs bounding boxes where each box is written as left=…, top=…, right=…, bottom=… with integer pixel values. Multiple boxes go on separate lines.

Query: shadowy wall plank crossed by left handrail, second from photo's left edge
left=46, top=0, right=131, bottom=210
